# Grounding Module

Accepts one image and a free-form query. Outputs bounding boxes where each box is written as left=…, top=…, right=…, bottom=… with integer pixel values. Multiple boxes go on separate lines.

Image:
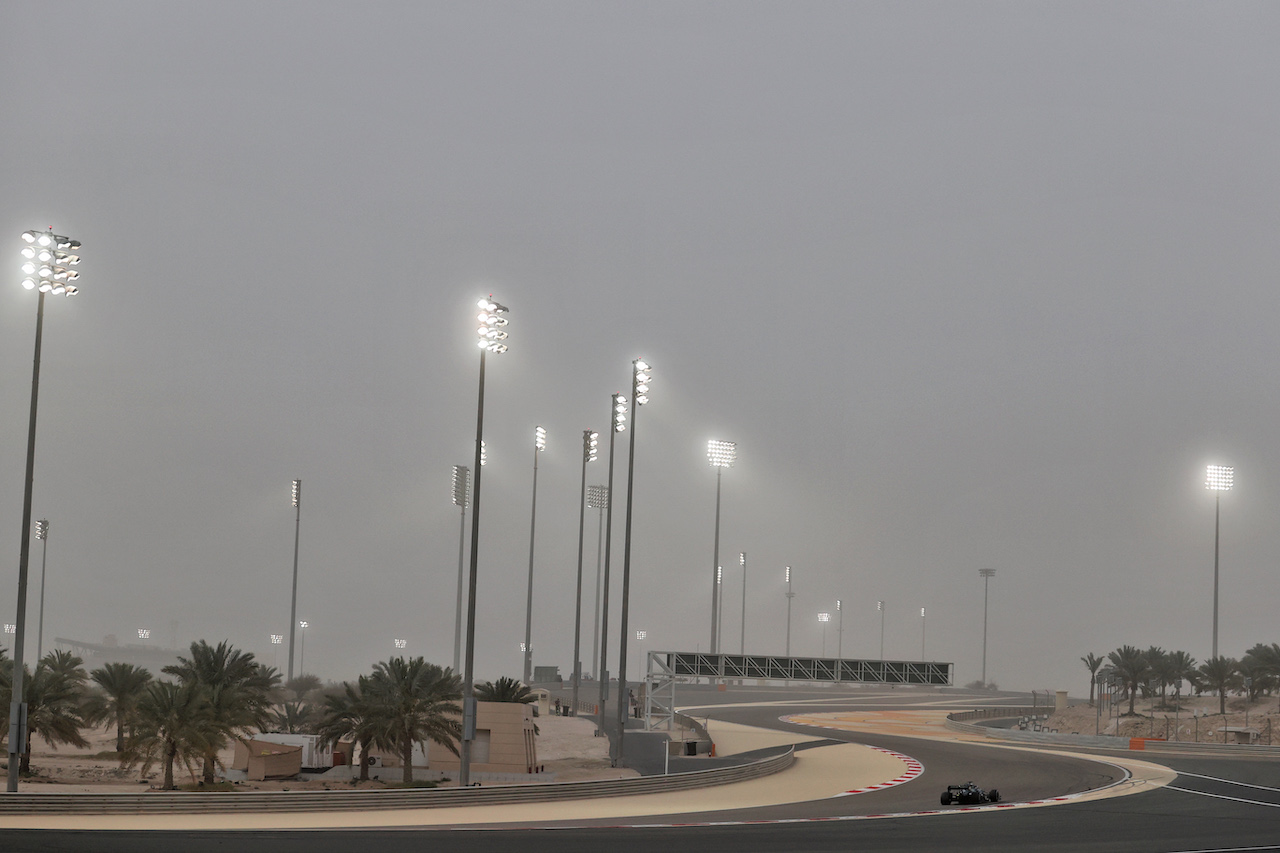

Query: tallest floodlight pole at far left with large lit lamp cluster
left=8, top=231, right=79, bottom=792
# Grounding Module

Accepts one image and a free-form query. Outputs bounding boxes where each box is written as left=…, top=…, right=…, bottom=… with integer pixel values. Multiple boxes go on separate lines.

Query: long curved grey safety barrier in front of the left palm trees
left=0, top=747, right=795, bottom=815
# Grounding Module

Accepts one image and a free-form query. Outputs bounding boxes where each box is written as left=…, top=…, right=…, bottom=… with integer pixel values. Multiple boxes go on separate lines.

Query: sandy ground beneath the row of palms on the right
left=1047, top=695, right=1280, bottom=745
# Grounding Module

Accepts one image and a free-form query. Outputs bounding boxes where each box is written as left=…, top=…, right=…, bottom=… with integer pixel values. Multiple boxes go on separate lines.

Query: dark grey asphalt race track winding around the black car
left=0, top=690, right=1280, bottom=853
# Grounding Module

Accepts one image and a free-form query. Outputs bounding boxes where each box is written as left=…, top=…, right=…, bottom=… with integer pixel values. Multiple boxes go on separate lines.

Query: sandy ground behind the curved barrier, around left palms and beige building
left=20, top=717, right=637, bottom=793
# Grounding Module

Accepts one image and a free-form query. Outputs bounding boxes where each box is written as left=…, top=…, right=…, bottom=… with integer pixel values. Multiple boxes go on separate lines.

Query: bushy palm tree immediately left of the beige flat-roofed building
left=366, top=657, right=462, bottom=784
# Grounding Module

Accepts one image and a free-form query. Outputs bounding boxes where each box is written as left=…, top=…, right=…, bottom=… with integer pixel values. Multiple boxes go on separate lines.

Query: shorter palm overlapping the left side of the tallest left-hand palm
left=123, top=681, right=213, bottom=790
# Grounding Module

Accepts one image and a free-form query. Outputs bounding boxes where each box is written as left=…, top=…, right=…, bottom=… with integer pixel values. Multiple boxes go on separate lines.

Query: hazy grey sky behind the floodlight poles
left=0, top=0, right=1280, bottom=694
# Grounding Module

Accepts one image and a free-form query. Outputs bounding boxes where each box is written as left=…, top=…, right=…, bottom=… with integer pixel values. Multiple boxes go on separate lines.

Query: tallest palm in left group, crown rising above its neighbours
left=164, top=640, right=280, bottom=785
